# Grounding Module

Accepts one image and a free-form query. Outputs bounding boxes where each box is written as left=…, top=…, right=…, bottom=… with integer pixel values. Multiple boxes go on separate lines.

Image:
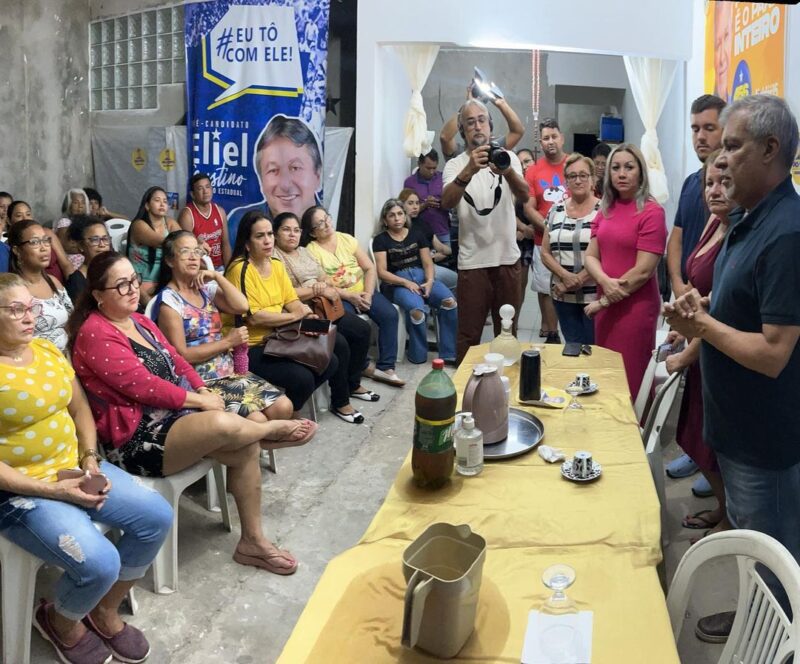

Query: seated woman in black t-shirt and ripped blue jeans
left=372, top=198, right=458, bottom=364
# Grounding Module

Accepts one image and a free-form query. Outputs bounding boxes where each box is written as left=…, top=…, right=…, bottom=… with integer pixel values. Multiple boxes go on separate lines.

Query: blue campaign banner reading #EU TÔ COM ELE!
left=185, top=0, right=330, bottom=241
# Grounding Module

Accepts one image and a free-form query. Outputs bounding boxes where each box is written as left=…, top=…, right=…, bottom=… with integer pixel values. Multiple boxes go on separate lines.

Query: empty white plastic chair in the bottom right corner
left=667, top=530, right=800, bottom=664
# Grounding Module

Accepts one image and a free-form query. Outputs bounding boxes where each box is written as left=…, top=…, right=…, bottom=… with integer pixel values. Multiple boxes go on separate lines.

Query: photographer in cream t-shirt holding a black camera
left=442, top=99, right=528, bottom=362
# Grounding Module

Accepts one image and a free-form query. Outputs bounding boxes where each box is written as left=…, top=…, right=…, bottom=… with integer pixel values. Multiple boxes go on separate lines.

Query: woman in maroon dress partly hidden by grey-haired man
left=667, top=150, right=734, bottom=537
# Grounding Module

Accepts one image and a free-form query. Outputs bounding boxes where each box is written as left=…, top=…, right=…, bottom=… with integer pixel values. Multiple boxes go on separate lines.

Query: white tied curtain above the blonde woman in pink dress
left=624, top=55, right=678, bottom=205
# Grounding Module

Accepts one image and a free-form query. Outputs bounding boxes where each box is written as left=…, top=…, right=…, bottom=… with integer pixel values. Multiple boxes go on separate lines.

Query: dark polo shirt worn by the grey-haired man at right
left=700, top=178, right=800, bottom=469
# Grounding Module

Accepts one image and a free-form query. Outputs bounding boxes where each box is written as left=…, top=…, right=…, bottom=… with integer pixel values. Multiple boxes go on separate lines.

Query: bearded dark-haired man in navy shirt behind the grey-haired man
left=667, top=95, right=725, bottom=482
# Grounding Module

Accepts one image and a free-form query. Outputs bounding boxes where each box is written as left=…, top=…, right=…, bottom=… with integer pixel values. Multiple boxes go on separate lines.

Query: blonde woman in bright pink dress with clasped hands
left=585, top=143, right=667, bottom=397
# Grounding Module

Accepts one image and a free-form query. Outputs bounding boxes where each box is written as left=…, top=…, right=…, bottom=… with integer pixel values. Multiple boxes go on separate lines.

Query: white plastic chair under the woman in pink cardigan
left=139, top=459, right=232, bottom=594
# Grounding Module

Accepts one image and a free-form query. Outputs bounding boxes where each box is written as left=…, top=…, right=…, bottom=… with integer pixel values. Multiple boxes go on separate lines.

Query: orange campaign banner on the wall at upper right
left=705, top=2, right=786, bottom=102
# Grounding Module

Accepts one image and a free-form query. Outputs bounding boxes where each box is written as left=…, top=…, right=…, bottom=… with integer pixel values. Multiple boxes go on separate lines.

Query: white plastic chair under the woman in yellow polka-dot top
left=0, top=522, right=138, bottom=664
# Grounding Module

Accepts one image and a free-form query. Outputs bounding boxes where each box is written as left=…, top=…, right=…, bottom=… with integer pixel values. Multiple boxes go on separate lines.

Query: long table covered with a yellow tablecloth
left=279, top=344, right=679, bottom=664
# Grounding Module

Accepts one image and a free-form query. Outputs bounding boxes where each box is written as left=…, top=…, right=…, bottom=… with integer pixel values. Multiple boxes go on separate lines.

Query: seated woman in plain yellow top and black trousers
left=225, top=210, right=364, bottom=424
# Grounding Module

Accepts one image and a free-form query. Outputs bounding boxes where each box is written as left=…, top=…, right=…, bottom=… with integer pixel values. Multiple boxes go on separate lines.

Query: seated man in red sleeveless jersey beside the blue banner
left=178, top=173, right=231, bottom=272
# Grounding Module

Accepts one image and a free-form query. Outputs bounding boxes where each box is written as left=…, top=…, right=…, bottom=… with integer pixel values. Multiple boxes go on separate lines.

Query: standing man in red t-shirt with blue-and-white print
left=525, top=118, right=567, bottom=344
